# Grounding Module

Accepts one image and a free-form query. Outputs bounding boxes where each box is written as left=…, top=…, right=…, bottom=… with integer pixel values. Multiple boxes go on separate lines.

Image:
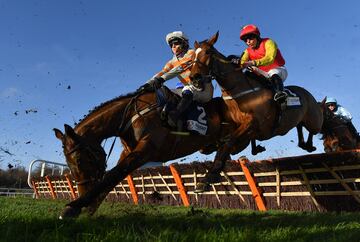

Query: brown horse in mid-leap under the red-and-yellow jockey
left=190, top=32, right=323, bottom=189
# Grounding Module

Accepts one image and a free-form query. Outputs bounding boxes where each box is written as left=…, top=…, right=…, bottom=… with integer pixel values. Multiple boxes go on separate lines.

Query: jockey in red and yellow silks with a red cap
left=235, top=24, right=287, bottom=102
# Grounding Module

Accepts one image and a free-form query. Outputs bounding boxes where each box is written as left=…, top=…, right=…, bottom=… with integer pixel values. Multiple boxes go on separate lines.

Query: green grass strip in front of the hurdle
left=0, top=197, right=360, bottom=242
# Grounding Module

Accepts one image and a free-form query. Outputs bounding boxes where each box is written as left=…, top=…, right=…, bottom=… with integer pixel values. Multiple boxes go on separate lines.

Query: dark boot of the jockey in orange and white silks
left=168, top=91, right=193, bottom=131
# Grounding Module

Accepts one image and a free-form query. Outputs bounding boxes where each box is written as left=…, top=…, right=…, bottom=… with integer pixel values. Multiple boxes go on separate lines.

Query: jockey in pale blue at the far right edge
left=325, top=97, right=360, bottom=141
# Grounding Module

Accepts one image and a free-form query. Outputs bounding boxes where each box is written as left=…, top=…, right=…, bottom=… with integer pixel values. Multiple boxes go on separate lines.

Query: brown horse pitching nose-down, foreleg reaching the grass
left=54, top=88, right=230, bottom=218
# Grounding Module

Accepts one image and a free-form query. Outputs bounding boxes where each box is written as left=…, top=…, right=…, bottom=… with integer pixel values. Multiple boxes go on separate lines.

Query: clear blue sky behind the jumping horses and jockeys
left=0, top=0, right=360, bottom=169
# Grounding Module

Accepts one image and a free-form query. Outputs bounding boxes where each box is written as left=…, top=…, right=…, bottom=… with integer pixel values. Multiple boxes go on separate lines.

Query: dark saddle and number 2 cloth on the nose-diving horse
left=155, top=86, right=208, bottom=135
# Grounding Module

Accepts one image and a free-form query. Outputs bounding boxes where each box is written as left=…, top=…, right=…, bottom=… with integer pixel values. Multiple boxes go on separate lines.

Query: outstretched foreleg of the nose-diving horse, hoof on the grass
left=60, top=141, right=152, bottom=218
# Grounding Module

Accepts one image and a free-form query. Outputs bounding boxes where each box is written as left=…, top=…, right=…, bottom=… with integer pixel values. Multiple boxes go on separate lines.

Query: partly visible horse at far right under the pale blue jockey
left=320, top=99, right=360, bottom=153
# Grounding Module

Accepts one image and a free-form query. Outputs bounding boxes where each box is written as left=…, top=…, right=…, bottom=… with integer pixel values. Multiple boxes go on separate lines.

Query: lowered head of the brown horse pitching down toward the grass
left=54, top=124, right=106, bottom=195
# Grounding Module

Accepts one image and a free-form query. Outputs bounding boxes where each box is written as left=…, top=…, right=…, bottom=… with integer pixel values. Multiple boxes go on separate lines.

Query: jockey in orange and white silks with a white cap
left=147, top=31, right=214, bottom=128
